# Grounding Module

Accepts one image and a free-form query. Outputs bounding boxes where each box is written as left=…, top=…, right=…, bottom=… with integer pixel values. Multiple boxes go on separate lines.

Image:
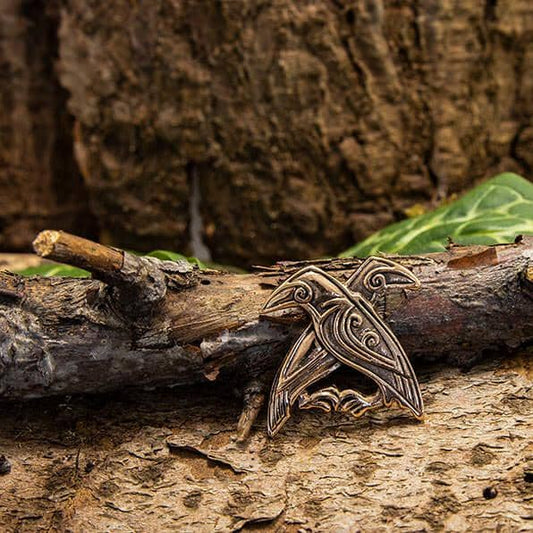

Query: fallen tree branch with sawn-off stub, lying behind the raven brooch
left=0, top=231, right=533, bottom=412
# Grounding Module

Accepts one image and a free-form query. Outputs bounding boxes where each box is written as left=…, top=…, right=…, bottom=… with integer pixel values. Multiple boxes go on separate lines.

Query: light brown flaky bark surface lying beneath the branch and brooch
left=0, top=353, right=533, bottom=533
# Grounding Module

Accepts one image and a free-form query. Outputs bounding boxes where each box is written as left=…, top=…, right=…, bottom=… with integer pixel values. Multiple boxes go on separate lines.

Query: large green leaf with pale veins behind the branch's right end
left=341, top=172, right=533, bottom=257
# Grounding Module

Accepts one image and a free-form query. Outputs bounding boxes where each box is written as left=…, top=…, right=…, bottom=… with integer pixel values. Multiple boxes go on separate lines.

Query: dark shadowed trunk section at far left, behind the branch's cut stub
left=0, top=0, right=95, bottom=251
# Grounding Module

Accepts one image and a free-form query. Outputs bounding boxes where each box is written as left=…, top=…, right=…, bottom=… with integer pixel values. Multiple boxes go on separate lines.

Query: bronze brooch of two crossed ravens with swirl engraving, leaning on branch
left=262, top=257, right=424, bottom=436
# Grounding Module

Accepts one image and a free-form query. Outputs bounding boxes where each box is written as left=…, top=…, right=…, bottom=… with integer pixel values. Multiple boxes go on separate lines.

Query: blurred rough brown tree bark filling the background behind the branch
left=0, top=0, right=533, bottom=265
